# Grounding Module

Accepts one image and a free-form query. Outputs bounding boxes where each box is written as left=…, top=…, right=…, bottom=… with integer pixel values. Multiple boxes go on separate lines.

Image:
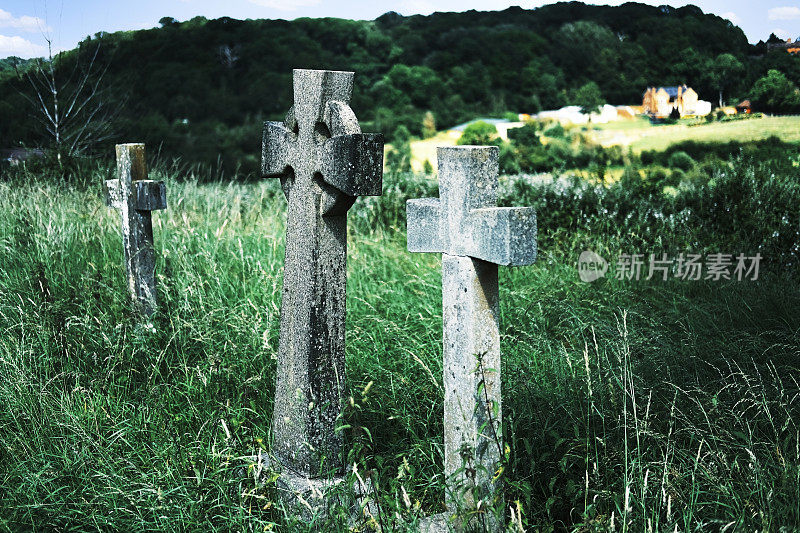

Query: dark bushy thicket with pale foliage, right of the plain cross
left=501, top=157, right=800, bottom=271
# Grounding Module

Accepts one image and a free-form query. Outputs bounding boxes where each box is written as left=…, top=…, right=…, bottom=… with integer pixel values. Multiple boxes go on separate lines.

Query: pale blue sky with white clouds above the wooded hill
left=0, top=0, right=800, bottom=58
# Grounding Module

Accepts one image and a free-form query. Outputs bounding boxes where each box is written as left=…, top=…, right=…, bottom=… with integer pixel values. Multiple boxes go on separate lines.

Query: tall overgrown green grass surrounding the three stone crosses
left=0, top=161, right=800, bottom=532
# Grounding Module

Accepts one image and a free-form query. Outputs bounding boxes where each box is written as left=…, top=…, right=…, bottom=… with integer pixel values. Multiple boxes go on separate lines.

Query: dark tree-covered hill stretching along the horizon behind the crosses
left=0, top=2, right=800, bottom=169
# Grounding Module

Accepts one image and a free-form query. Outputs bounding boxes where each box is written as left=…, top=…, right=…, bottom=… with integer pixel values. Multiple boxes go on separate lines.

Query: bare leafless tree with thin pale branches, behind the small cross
left=17, top=39, right=112, bottom=164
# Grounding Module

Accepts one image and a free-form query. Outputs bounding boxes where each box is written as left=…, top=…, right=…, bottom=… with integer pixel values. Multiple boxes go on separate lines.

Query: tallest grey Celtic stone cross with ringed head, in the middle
left=262, top=70, right=383, bottom=478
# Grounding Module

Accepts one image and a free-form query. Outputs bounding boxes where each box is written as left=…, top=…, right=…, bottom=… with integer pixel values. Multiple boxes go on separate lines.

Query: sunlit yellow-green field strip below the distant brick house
left=595, top=116, right=800, bottom=152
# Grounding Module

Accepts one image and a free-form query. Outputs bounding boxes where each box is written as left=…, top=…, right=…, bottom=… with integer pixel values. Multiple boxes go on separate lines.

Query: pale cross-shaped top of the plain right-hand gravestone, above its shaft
left=406, top=147, right=536, bottom=266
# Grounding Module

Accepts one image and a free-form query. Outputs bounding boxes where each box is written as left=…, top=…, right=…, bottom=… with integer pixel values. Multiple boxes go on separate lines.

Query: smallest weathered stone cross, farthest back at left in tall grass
left=105, top=144, right=167, bottom=316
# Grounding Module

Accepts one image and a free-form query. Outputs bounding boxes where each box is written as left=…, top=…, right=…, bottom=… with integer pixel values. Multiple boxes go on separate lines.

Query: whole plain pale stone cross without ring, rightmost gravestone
left=407, top=146, right=536, bottom=531
